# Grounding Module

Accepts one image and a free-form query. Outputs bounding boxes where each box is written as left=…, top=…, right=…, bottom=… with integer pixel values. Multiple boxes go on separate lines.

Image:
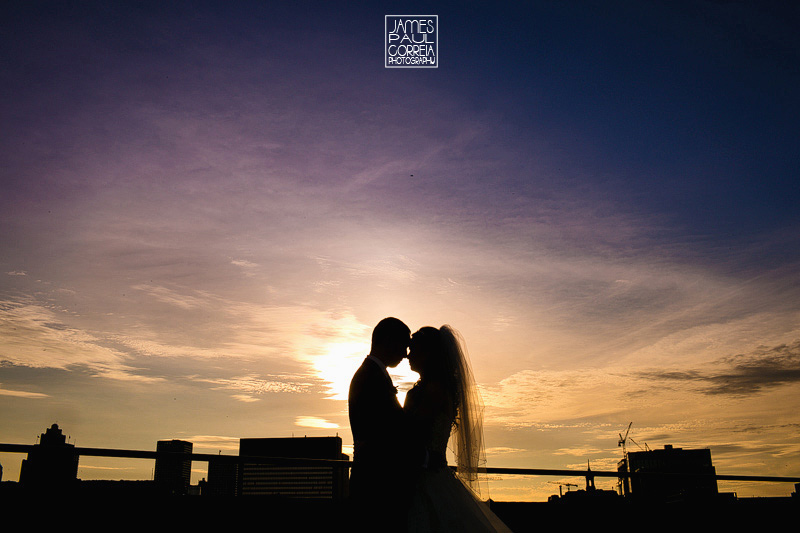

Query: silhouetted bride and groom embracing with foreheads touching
left=349, top=318, right=509, bottom=532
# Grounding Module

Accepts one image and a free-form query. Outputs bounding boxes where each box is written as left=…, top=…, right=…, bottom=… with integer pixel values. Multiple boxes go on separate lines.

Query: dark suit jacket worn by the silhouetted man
left=348, top=358, right=408, bottom=498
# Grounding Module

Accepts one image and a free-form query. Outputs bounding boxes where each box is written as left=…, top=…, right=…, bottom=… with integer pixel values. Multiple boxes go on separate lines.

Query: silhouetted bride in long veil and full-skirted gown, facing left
left=403, top=325, right=510, bottom=532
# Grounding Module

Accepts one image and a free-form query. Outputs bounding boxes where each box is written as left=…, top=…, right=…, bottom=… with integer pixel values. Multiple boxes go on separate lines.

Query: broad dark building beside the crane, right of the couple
left=617, top=444, right=719, bottom=501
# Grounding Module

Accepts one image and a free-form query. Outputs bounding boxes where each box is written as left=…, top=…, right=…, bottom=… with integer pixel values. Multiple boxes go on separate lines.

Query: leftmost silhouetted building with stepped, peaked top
left=19, top=424, right=78, bottom=489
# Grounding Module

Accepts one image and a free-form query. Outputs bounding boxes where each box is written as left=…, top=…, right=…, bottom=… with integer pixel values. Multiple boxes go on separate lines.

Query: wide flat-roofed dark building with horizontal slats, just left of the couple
left=238, top=437, right=348, bottom=500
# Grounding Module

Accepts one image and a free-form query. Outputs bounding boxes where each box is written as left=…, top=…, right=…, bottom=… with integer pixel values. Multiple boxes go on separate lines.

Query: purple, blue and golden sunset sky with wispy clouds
left=0, top=0, right=800, bottom=500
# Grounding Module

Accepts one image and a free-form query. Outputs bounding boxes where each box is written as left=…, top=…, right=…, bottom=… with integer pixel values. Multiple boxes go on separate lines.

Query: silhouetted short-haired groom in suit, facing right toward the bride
left=348, top=317, right=413, bottom=530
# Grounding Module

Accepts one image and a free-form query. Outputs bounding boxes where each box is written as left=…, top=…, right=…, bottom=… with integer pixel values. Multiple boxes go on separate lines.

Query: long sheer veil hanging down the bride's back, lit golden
left=439, top=325, right=486, bottom=496
